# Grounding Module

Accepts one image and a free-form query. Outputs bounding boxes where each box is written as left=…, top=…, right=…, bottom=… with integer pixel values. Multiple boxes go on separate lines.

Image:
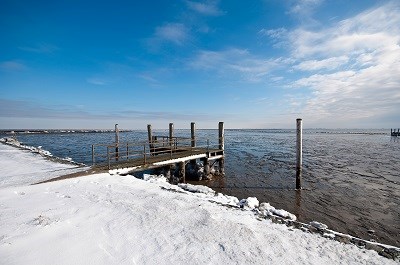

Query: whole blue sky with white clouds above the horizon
left=0, top=0, right=400, bottom=129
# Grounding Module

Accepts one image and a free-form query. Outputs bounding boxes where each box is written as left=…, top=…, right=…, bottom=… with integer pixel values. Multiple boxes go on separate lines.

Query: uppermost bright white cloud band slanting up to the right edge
left=287, top=2, right=400, bottom=58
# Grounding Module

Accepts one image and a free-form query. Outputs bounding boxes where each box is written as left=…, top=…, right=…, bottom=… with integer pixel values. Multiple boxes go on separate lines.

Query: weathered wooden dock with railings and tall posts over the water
left=92, top=122, right=224, bottom=182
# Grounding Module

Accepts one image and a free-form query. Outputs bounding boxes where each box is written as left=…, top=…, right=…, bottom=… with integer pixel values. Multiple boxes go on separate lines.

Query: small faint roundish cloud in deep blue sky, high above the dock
left=154, top=23, right=189, bottom=45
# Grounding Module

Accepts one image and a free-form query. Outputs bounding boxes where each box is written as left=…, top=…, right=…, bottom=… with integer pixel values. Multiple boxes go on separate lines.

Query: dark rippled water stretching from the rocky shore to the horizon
left=2, top=130, right=400, bottom=246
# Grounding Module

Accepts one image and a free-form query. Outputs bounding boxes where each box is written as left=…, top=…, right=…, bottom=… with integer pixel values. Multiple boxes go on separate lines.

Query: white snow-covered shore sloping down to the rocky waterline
left=0, top=144, right=398, bottom=264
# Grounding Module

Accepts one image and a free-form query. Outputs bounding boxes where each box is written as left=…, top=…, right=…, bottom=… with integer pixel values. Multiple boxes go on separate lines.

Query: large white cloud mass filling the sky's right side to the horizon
left=270, top=1, right=400, bottom=127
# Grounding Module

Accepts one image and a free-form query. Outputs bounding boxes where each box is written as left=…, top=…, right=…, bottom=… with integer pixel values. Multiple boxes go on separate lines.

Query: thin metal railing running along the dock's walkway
left=92, top=136, right=222, bottom=169
